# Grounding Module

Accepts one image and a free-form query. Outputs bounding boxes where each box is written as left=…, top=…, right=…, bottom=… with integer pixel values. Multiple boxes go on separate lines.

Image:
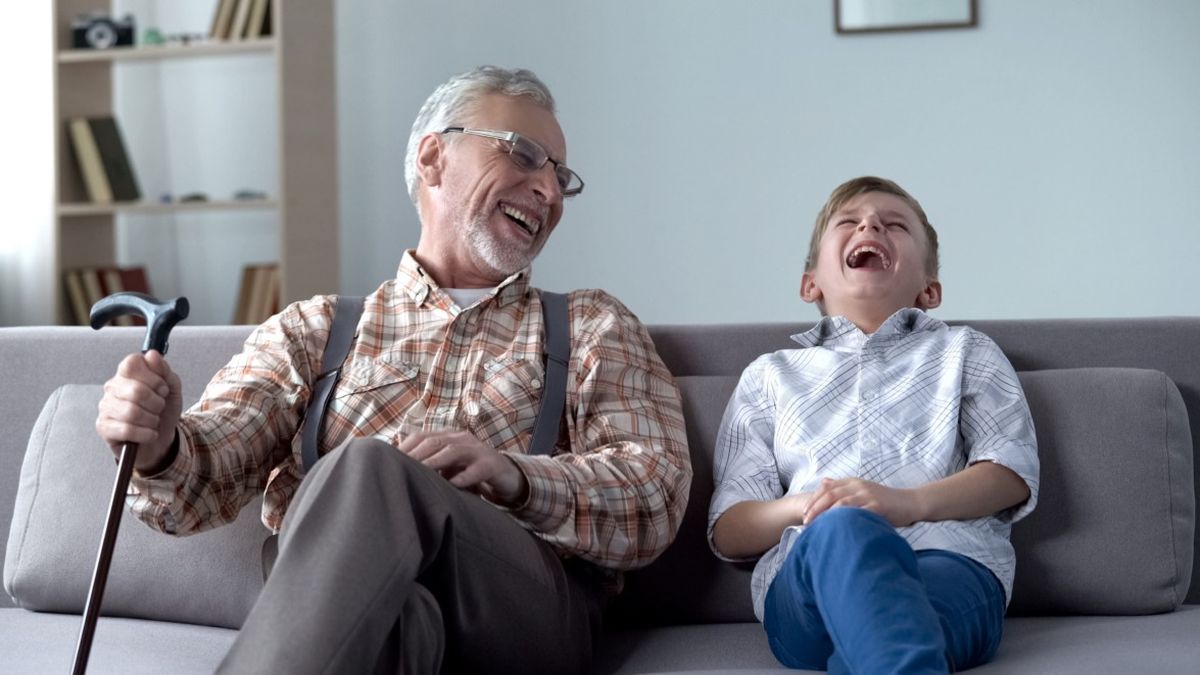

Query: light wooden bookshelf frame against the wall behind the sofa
left=48, top=0, right=340, bottom=323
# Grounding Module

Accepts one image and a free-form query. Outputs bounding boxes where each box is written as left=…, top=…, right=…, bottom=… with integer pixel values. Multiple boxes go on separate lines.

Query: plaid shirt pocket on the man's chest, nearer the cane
left=322, top=358, right=421, bottom=439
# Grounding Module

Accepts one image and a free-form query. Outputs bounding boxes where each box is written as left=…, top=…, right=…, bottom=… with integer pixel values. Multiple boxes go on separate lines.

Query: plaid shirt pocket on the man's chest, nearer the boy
left=463, top=357, right=545, bottom=450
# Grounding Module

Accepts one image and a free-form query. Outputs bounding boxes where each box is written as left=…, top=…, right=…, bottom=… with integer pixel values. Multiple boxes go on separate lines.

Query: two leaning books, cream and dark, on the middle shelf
left=67, top=115, right=142, bottom=204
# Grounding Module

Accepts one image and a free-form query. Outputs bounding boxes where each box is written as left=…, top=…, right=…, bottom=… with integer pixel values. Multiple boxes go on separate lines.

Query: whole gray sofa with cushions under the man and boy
left=0, top=318, right=1200, bottom=674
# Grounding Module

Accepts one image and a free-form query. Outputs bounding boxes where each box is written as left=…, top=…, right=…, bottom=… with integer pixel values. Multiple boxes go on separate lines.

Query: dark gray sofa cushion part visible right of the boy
left=1009, top=368, right=1195, bottom=615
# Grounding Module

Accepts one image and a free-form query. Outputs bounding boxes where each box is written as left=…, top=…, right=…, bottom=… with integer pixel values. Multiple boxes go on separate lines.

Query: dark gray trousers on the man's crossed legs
left=220, top=438, right=600, bottom=675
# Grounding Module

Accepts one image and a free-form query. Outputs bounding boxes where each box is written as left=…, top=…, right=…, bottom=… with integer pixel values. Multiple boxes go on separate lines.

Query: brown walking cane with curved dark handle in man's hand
left=72, top=293, right=187, bottom=675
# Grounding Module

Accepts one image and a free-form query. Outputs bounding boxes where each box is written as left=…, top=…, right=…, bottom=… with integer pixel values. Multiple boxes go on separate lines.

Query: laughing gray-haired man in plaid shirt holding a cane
left=96, top=67, right=691, bottom=673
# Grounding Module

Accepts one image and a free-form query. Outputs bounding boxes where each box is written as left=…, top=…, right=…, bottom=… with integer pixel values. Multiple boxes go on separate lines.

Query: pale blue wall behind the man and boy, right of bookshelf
left=337, top=0, right=1200, bottom=323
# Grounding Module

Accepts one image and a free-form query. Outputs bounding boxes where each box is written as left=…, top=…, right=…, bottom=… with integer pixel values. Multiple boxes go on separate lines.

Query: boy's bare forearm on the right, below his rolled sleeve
left=916, top=461, right=1030, bottom=521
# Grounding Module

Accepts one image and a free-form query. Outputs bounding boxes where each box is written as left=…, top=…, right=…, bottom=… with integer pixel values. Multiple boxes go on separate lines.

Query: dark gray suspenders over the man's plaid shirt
left=300, top=291, right=571, bottom=473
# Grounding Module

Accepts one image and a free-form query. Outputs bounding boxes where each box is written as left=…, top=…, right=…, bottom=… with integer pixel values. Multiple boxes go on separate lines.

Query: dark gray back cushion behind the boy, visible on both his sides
left=610, top=368, right=1195, bottom=626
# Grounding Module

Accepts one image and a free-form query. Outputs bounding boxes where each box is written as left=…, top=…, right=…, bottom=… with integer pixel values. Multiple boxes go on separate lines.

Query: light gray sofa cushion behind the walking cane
left=4, top=384, right=269, bottom=627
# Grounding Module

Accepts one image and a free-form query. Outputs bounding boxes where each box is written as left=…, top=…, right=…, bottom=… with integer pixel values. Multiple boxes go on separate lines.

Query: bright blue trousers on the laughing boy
left=763, top=508, right=1004, bottom=674
